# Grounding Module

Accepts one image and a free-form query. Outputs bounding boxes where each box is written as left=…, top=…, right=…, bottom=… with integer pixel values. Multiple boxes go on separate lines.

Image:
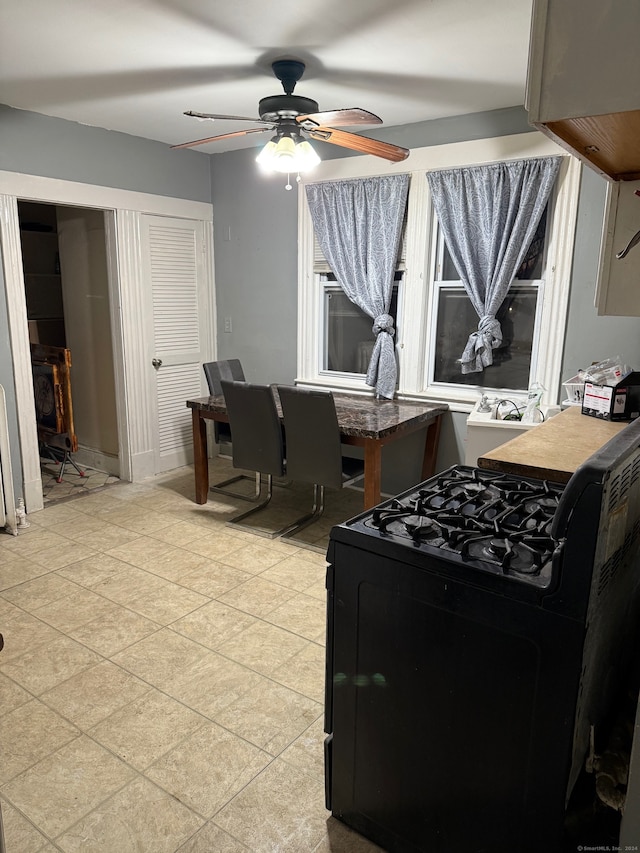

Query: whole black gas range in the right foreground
left=325, top=422, right=640, bottom=853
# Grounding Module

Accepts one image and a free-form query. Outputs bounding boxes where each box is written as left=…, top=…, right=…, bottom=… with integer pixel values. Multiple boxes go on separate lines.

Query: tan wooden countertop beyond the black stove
left=478, top=406, right=629, bottom=483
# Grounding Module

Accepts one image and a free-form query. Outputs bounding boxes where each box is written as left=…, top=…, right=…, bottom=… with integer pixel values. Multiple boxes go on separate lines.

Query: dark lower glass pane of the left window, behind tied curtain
left=323, top=286, right=398, bottom=373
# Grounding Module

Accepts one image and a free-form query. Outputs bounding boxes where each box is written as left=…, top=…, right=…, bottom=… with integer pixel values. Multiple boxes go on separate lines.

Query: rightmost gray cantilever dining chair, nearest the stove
left=277, top=385, right=364, bottom=538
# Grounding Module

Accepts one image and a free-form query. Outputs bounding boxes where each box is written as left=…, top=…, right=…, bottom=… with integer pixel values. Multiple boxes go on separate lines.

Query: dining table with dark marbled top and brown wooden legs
left=187, top=393, right=448, bottom=509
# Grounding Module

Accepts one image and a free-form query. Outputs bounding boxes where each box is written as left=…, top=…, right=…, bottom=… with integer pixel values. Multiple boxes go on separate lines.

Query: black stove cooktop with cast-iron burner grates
left=354, top=466, right=564, bottom=586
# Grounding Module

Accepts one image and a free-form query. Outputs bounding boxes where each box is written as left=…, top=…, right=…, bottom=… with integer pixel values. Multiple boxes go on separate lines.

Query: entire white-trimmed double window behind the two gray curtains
left=296, top=131, right=581, bottom=411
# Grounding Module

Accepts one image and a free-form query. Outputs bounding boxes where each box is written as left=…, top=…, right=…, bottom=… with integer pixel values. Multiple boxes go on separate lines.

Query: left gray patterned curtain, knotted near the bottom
left=307, top=175, right=409, bottom=399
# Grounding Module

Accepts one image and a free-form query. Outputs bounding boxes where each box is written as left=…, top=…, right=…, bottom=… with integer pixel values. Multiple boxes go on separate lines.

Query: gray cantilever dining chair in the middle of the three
left=221, top=379, right=296, bottom=539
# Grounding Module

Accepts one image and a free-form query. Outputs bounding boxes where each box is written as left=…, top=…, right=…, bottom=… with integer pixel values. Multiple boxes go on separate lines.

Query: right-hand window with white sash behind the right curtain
left=430, top=210, right=547, bottom=391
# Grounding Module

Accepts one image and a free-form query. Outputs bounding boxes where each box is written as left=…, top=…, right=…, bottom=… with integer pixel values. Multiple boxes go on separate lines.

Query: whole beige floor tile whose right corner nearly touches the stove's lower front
left=215, top=679, right=322, bottom=755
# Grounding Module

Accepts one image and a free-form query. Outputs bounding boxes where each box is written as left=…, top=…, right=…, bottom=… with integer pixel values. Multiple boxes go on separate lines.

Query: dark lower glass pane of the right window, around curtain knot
left=434, top=285, right=538, bottom=391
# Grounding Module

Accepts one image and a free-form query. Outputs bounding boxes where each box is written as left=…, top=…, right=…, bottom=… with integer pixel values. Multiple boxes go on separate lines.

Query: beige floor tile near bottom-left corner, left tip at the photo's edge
left=2, top=735, right=135, bottom=838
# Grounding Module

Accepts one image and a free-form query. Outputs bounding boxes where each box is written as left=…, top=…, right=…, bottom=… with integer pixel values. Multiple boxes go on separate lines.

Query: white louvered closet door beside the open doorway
left=142, top=216, right=207, bottom=473
